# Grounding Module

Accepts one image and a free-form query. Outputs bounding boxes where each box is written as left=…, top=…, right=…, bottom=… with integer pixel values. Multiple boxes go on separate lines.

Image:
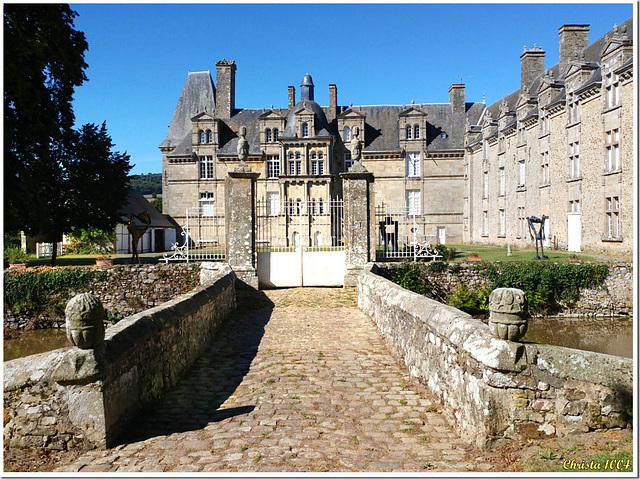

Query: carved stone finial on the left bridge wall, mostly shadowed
left=64, top=293, right=105, bottom=349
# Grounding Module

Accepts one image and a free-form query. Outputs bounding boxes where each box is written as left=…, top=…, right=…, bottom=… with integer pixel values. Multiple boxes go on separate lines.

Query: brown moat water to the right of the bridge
left=522, top=317, right=633, bottom=358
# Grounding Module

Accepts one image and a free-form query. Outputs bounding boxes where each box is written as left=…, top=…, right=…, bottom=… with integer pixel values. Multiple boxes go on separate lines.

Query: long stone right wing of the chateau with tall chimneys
left=464, top=19, right=634, bottom=255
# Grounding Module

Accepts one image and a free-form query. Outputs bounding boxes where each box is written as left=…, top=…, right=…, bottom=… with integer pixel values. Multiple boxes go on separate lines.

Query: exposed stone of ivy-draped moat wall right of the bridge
left=376, top=262, right=633, bottom=316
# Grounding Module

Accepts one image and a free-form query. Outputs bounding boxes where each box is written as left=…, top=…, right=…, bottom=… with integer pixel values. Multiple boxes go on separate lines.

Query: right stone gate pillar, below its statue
left=340, top=162, right=375, bottom=287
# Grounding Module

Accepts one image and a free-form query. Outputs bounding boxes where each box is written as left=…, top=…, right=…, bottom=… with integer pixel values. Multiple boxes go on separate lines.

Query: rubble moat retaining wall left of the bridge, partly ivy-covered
left=4, top=263, right=200, bottom=330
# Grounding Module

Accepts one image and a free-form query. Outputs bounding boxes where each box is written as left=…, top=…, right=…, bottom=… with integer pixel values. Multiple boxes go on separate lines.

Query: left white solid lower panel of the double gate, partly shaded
left=258, top=248, right=302, bottom=287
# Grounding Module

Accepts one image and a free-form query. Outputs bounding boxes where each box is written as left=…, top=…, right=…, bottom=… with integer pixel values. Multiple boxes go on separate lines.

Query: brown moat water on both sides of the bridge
left=4, top=317, right=633, bottom=361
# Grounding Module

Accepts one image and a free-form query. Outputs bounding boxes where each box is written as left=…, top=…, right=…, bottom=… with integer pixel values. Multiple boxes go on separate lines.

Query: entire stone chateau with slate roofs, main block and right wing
left=159, top=20, right=634, bottom=253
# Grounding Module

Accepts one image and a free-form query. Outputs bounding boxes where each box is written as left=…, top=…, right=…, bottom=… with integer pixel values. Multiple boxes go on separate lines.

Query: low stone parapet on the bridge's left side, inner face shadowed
left=4, top=264, right=235, bottom=450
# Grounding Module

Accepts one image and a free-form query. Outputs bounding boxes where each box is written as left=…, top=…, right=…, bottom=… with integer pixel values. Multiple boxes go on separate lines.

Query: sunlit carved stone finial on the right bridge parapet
left=489, top=288, right=527, bottom=342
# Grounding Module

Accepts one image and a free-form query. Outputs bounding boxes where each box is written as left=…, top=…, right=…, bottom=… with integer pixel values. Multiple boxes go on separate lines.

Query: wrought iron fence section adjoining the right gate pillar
left=375, top=204, right=441, bottom=260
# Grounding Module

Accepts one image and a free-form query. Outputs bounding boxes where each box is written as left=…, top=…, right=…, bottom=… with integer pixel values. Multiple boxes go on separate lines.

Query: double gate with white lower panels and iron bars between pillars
left=256, top=200, right=345, bottom=287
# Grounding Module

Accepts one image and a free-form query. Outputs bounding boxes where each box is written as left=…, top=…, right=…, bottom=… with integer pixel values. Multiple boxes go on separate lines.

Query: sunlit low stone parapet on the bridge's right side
left=358, top=264, right=633, bottom=447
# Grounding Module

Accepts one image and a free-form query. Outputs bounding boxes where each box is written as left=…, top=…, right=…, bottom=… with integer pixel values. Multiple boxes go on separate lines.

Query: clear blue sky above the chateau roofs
left=71, top=2, right=633, bottom=173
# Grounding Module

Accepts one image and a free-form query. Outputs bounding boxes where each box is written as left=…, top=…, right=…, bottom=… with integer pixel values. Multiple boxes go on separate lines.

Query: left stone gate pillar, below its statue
left=224, top=167, right=260, bottom=288
